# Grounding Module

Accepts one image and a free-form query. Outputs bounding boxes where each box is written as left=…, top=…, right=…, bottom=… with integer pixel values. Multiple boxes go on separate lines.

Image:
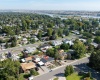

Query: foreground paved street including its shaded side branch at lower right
left=34, top=58, right=100, bottom=80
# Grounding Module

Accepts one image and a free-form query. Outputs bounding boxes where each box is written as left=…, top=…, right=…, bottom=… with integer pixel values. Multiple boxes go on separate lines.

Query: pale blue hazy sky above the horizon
left=0, top=0, right=100, bottom=11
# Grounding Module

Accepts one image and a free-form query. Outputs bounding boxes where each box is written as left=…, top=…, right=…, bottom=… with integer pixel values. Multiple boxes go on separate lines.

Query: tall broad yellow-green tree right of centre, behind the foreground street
left=73, top=40, right=86, bottom=58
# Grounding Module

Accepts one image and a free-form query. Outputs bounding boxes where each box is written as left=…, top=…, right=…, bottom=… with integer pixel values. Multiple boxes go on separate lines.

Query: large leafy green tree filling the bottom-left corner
left=0, top=59, right=20, bottom=80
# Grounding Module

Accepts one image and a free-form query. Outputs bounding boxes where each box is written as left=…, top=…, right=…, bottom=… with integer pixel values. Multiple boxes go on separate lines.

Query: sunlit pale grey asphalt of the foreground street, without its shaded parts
left=34, top=58, right=88, bottom=80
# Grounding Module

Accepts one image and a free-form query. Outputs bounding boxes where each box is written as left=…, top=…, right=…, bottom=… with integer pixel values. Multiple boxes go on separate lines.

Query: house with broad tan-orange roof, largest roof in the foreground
left=21, top=62, right=36, bottom=72
